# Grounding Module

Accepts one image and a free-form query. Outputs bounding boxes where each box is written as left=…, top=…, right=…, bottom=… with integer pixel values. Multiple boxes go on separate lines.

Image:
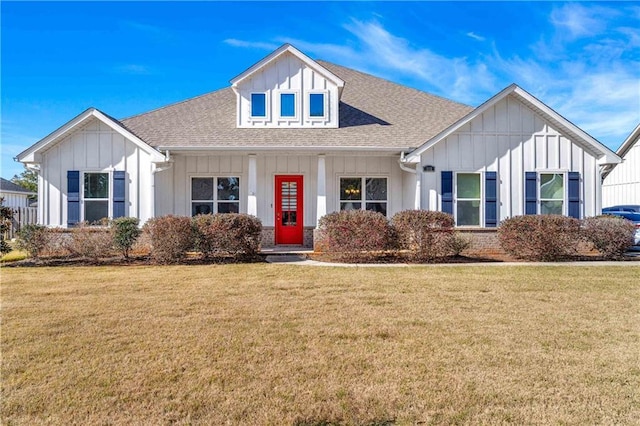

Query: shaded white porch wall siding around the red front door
left=155, top=153, right=403, bottom=227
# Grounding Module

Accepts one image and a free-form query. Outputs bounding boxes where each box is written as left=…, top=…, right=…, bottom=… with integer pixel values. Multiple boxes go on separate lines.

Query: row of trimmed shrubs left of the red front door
left=17, top=213, right=262, bottom=263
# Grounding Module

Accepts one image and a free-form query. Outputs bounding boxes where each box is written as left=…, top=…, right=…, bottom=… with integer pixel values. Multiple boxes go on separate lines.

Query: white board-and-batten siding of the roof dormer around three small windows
left=237, top=53, right=339, bottom=128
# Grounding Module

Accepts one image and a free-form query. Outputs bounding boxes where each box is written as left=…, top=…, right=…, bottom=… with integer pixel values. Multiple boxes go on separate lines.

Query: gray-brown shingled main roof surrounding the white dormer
left=120, top=61, right=473, bottom=150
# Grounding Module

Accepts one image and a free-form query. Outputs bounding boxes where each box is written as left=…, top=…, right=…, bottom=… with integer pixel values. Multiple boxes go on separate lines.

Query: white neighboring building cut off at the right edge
left=602, top=124, right=640, bottom=207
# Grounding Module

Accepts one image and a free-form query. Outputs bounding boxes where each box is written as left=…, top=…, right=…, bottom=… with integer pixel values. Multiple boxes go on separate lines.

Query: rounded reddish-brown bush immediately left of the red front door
left=193, top=213, right=262, bottom=257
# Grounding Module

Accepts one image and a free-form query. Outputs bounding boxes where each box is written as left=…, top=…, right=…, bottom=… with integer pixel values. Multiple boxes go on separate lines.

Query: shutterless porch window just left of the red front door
left=191, top=177, right=240, bottom=216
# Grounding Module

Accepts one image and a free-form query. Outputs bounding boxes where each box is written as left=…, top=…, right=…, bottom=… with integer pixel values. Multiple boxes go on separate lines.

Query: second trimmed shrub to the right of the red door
left=391, top=210, right=455, bottom=261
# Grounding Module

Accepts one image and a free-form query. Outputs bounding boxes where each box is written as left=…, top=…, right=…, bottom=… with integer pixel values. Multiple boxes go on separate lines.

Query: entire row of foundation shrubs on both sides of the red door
left=17, top=210, right=634, bottom=263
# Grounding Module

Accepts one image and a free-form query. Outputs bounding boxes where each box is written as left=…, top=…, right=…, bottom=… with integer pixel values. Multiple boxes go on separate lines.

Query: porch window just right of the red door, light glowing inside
left=340, top=177, right=388, bottom=216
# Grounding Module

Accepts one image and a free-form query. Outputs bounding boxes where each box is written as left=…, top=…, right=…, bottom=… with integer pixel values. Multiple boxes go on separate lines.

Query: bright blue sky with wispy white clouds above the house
left=0, top=1, right=640, bottom=178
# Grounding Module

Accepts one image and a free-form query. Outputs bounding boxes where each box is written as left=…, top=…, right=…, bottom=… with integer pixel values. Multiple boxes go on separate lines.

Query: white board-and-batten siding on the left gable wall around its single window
left=38, top=119, right=153, bottom=227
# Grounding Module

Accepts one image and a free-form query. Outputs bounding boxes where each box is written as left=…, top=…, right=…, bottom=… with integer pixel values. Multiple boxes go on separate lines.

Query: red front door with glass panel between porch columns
left=275, top=175, right=303, bottom=244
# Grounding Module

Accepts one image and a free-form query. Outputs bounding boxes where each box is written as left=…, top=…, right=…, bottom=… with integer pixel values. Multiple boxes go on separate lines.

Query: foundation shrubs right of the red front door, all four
left=320, top=210, right=634, bottom=262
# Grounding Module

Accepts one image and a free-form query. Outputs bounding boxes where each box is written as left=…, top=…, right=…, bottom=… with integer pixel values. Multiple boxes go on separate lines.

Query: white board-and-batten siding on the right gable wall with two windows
left=419, top=96, right=599, bottom=221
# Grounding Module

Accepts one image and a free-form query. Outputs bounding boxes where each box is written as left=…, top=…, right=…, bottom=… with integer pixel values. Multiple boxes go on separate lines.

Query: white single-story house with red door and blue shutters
left=18, top=44, right=621, bottom=246
